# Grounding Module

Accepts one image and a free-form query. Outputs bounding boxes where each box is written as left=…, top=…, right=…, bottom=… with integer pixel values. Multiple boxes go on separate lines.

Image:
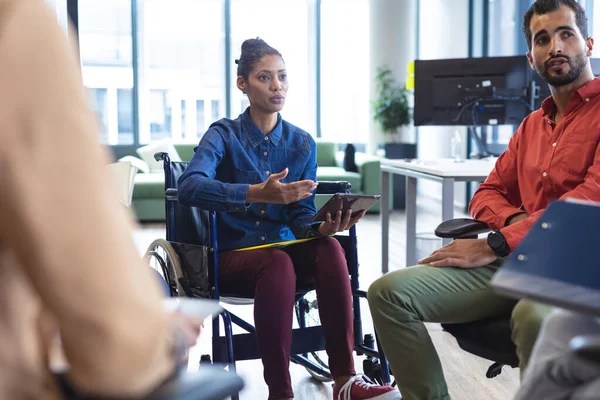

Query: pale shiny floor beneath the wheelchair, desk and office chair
left=135, top=204, right=519, bottom=400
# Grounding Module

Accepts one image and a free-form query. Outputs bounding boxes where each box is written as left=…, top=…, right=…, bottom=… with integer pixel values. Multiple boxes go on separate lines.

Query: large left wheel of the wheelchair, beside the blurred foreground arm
left=144, top=239, right=185, bottom=297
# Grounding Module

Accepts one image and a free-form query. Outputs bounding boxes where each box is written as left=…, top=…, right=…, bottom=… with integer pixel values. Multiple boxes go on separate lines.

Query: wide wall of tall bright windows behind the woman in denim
left=75, top=0, right=382, bottom=147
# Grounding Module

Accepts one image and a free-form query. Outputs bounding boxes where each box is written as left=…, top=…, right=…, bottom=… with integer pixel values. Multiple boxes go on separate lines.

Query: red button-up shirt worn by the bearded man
left=469, top=78, right=600, bottom=249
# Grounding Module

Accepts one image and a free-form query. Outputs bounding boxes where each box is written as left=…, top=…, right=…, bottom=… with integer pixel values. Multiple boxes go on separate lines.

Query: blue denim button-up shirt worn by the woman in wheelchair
left=178, top=108, right=320, bottom=251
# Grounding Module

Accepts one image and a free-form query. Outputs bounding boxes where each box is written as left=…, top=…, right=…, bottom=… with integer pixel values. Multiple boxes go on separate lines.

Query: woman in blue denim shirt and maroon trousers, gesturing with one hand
left=179, top=38, right=400, bottom=400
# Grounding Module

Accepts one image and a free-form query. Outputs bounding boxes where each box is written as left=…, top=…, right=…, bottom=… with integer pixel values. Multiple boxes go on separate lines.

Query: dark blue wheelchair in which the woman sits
left=146, top=153, right=390, bottom=399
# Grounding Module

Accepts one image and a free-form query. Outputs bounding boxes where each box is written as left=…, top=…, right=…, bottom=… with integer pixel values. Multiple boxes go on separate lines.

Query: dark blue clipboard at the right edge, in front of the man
left=492, top=201, right=600, bottom=316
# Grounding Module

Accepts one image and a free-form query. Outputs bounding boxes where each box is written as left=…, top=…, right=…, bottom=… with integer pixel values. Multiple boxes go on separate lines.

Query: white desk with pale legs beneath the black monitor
left=380, top=158, right=496, bottom=274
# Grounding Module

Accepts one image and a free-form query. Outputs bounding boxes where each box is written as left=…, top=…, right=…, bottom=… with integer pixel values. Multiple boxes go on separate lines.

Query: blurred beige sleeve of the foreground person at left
left=0, top=0, right=174, bottom=395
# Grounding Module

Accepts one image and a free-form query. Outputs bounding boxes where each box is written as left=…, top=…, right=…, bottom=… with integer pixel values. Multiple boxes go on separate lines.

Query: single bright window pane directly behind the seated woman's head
left=227, top=0, right=316, bottom=136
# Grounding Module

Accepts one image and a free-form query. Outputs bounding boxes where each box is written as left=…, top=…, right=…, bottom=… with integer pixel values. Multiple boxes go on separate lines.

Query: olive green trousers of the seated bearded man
left=367, top=264, right=551, bottom=400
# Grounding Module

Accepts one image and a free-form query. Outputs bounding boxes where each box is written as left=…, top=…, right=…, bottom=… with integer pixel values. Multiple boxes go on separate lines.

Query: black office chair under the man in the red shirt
left=435, top=218, right=519, bottom=379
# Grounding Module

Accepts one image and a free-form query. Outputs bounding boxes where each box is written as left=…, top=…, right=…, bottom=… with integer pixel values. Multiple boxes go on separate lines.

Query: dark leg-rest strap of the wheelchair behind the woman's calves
left=213, top=326, right=325, bottom=363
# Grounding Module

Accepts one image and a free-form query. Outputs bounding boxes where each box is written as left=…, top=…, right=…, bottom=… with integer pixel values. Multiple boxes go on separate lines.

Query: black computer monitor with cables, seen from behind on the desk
left=414, top=56, right=537, bottom=126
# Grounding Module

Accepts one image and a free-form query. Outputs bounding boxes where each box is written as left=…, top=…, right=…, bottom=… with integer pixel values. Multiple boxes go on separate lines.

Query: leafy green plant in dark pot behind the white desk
left=373, top=66, right=417, bottom=209
